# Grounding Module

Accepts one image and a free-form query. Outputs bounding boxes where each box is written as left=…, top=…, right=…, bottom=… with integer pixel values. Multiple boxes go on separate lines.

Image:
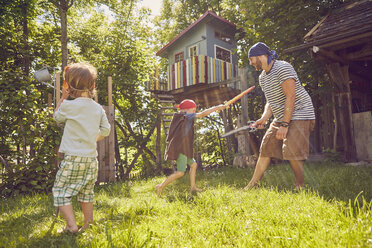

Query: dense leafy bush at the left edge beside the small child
left=0, top=72, right=61, bottom=197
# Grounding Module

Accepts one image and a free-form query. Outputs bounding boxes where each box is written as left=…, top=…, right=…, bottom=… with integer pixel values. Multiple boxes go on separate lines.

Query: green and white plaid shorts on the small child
left=52, top=155, right=98, bottom=207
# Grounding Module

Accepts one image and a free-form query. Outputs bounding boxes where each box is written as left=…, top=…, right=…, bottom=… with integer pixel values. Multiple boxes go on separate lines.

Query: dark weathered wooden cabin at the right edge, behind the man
left=284, top=0, right=372, bottom=161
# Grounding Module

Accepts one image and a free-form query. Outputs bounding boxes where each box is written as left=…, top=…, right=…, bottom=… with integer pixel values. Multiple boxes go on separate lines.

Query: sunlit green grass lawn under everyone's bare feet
left=0, top=163, right=372, bottom=247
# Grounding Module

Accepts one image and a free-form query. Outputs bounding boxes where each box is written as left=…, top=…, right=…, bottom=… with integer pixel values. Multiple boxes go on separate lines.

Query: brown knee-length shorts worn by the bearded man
left=260, top=120, right=315, bottom=160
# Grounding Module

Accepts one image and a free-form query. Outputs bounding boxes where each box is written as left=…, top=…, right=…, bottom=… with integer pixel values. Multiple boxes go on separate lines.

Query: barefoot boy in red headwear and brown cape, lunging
left=156, top=99, right=227, bottom=196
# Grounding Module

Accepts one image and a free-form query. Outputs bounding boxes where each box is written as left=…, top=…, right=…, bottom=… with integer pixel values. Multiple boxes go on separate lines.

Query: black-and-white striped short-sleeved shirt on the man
left=259, top=60, right=315, bottom=120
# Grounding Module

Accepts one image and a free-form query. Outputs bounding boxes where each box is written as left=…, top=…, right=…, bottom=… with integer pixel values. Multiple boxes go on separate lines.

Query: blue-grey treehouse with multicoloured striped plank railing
left=152, top=11, right=240, bottom=107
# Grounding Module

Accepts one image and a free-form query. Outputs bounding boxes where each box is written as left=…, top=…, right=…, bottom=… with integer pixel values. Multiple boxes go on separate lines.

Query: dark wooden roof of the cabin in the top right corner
left=284, top=0, right=372, bottom=54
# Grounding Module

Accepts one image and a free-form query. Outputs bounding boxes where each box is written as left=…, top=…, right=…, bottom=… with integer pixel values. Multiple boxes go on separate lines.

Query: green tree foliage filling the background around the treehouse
left=0, top=0, right=349, bottom=195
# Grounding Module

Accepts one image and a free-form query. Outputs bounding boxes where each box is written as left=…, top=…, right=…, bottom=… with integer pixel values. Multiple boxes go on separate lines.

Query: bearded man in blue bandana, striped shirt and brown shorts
left=245, top=42, right=315, bottom=189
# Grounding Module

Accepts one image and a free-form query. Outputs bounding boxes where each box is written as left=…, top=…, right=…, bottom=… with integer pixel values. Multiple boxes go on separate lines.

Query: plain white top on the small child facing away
left=53, top=97, right=110, bottom=157
